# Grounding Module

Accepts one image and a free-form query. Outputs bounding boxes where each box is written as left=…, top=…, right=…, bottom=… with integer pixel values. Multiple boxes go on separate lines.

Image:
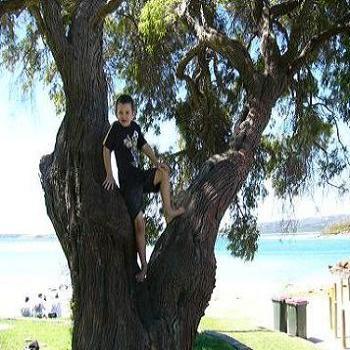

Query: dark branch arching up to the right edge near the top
left=289, top=22, right=350, bottom=74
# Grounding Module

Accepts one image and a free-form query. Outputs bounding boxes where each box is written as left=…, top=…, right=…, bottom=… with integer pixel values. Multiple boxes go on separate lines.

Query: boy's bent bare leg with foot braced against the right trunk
left=153, top=169, right=185, bottom=224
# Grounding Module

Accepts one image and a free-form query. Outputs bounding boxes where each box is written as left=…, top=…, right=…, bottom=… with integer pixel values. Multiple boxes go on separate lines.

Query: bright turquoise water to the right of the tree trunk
left=215, top=234, right=350, bottom=283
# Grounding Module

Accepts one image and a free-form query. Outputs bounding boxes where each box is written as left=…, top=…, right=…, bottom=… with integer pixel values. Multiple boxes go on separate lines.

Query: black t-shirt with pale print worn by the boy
left=103, top=120, right=147, bottom=188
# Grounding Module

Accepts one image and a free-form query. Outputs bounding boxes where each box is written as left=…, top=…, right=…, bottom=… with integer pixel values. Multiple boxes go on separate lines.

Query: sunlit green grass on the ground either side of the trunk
left=0, top=316, right=317, bottom=350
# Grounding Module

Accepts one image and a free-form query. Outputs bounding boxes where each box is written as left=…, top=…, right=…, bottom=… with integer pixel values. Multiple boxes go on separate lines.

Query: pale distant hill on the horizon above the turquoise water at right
left=259, top=215, right=350, bottom=234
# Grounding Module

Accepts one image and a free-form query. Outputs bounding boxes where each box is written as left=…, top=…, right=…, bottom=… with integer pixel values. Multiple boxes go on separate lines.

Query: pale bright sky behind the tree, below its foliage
left=0, top=73, right=350, bottom=235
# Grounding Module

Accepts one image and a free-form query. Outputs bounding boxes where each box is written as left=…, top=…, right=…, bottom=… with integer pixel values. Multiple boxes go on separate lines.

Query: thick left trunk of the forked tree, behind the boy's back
left=40, top=7, right=149, bottom=350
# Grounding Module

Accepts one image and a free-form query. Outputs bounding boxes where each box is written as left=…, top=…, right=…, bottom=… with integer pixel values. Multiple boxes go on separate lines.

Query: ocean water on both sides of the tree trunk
left=0, top=233, right=350, bottom=317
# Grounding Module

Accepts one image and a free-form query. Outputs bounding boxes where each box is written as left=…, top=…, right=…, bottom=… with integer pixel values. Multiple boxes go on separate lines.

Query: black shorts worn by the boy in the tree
left=120, top=168, right=160, bottom=221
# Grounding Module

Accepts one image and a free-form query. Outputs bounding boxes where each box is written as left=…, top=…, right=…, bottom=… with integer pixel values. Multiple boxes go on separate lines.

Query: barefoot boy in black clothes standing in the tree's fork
left=103, top=95, right=185, bottom=282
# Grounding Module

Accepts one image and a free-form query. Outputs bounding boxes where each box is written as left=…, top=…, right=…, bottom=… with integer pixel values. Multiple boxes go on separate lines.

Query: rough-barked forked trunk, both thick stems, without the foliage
left=40, top=4, right=273, bottom=350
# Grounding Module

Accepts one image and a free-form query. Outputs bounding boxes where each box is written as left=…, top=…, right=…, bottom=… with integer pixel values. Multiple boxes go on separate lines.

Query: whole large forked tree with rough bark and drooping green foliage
left=0, top=0, right=350, bottom=349
